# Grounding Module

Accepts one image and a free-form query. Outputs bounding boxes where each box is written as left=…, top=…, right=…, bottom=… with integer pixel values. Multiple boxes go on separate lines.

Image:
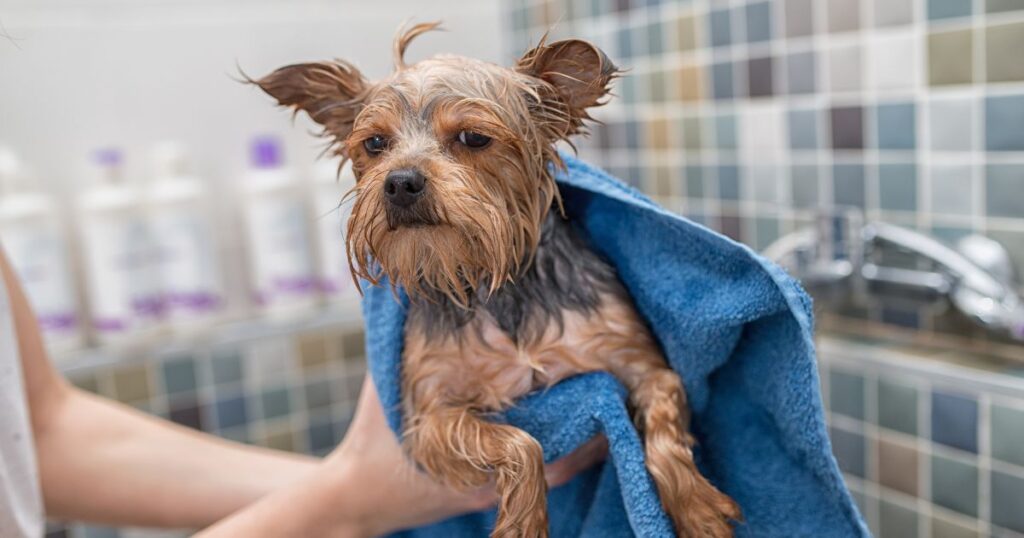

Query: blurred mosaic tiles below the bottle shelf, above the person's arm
left=47, top=315, right=366, bottom=538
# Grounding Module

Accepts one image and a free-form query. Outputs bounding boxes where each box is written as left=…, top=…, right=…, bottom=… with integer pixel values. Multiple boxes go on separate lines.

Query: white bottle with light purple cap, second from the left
left=78, top=150, right=164, bottom=342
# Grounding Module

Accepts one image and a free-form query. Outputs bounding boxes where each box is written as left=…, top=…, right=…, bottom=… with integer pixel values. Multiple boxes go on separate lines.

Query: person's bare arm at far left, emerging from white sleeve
left=0, top=251, right=318, bottom=528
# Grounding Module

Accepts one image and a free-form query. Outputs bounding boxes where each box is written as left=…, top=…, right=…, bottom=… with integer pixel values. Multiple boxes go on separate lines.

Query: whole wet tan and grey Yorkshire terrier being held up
left=253, top=23, right=740, bottom=537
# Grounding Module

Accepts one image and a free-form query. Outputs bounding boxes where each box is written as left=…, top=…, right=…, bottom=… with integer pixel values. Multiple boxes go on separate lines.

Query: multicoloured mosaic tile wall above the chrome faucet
left=507, top=0, right=1024, bottom=336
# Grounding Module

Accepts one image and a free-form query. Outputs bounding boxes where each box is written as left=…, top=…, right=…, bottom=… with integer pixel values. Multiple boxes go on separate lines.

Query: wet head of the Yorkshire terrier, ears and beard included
left=255, top=24, right=616, bottom=304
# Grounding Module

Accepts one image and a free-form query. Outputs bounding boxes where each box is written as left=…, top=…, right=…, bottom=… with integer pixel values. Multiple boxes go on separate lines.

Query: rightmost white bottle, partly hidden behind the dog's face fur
left=311, top=160, right=359, bottom=308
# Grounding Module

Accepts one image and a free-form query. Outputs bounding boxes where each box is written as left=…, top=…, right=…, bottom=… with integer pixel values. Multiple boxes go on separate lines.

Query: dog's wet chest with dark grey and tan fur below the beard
left=402, top=217, right=656, bottom=410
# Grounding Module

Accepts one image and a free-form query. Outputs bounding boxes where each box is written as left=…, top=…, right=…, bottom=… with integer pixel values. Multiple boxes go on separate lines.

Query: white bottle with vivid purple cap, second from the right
left=242, top=137, right=316, bottom=314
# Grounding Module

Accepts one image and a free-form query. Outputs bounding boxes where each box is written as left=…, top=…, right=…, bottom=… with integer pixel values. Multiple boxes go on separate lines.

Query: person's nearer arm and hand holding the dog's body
left=197, top=376, right=607, bottom=538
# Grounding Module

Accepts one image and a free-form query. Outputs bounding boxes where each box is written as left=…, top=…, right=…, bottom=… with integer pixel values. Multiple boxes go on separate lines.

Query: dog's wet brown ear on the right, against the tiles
left=514, top=39, right=618, bottom=134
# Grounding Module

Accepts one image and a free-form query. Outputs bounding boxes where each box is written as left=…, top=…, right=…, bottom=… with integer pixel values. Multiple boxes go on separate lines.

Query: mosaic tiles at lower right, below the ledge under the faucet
left=820, top=342, right=1024, bottom=538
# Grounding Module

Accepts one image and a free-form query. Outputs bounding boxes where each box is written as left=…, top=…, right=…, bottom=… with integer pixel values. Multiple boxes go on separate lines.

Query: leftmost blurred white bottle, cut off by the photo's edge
left=0, top=148, right=82, bottom=350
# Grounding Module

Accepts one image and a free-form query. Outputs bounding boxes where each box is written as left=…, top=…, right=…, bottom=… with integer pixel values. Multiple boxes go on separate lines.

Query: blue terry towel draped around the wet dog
left=362, top=155, right=868, bottom=538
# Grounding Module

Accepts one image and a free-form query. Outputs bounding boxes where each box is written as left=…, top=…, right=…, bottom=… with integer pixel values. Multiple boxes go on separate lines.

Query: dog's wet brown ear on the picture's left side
left=249, top=60, right=371, bottom=139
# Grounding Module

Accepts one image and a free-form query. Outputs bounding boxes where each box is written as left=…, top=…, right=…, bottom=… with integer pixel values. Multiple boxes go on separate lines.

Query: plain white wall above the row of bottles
left=0, top=0, right=502, bottom=192
